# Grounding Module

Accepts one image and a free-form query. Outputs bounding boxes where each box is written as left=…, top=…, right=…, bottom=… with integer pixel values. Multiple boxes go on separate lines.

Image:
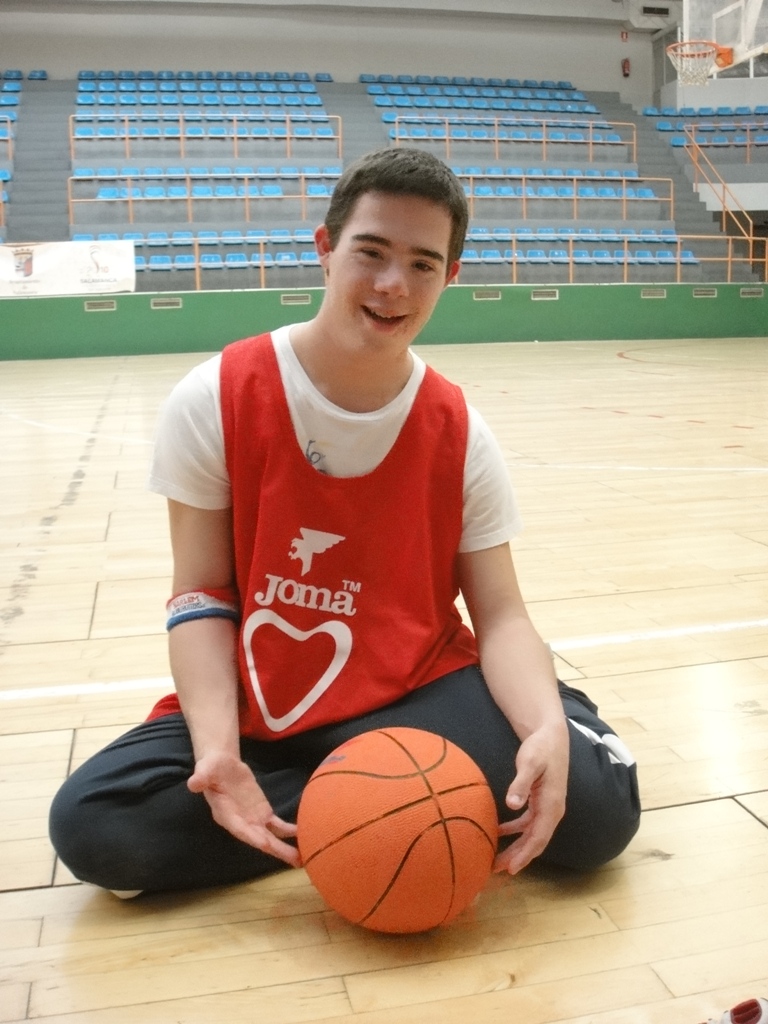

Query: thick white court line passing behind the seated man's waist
left=0, top=618, right=768, bottom=703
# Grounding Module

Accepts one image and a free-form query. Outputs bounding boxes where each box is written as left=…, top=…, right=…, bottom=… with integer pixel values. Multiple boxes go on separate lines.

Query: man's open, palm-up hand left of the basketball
left=186, top=753, right=301, bottom=867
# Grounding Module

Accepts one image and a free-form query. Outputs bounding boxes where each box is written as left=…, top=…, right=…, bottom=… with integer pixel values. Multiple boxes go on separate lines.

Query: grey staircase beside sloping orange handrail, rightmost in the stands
left=588, top=92, right=758, bottom=282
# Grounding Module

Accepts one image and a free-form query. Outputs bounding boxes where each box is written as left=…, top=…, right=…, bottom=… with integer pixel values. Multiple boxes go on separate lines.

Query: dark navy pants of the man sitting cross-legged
left=50, top=667, right=640, bottom=891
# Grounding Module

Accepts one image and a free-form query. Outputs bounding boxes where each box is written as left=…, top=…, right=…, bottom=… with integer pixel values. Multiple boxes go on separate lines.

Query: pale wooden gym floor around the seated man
left=0, top=339, right=768, bottom=1024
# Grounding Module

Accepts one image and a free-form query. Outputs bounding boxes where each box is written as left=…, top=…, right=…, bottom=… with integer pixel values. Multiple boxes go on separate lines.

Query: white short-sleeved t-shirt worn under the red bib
left=150, top=327, right=520, bottom=552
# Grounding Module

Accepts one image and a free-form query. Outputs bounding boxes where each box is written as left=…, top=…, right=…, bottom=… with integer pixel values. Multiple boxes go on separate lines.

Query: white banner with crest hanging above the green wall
left=0, top=242, right=136, bottom=296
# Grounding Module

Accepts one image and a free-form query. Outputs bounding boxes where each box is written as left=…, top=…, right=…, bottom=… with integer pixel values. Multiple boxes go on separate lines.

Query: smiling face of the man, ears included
left=315, top=193, right=459, bottom=351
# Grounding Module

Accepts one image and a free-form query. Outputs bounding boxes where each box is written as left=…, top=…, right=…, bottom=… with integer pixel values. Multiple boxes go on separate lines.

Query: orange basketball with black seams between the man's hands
left=297, top=728, right=498, bottom=932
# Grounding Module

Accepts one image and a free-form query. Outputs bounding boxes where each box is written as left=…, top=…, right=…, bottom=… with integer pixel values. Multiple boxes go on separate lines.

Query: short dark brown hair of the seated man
left=326, top=146, right=469, bottom=265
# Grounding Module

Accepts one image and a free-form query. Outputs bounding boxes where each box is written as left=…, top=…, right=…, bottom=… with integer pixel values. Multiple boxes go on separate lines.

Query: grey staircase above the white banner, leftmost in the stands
left=5, top=81, right=77, bottom=243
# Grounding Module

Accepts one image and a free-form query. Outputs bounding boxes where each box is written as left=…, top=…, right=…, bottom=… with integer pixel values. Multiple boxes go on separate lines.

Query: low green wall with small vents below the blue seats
left=0, top=285, right=768, bottom=359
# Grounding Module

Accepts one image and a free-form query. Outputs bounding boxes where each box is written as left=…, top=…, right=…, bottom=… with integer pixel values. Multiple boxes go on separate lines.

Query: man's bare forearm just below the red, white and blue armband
left=169, top=618, right=240, bottom=761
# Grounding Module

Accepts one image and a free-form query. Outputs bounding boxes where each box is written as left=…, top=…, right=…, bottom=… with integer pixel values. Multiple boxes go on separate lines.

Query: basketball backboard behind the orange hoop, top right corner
left=682, top=0, right=768, bottom=63
